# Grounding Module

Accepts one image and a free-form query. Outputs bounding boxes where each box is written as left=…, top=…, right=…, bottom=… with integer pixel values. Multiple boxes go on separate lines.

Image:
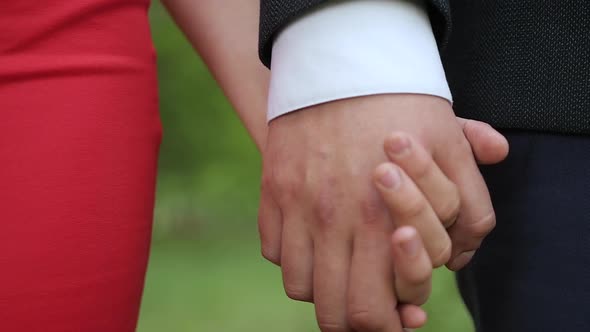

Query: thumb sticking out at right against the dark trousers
left=457, top=117, right=509, bottom=165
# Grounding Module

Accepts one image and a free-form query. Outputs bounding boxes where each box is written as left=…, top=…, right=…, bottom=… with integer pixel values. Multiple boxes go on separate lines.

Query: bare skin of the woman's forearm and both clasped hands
left=164, top=0, right=507, bottom=332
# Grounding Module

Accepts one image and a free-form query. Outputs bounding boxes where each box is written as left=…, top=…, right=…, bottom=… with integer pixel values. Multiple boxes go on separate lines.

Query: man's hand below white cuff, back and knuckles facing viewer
left=259, top=95, right=505, bottom=331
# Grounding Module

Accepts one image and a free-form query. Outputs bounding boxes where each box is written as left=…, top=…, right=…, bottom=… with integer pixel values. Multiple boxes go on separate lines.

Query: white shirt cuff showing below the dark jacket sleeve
left=267, top=0, right=452, bottom=121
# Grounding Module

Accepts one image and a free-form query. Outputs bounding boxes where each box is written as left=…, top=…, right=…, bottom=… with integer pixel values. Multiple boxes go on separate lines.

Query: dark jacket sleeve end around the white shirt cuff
left=258, top=0, right=451, bottom=68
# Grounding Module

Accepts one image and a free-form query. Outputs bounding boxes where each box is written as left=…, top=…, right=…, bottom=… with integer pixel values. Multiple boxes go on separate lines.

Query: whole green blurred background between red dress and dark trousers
left=138, top=3, right=473, bottom=332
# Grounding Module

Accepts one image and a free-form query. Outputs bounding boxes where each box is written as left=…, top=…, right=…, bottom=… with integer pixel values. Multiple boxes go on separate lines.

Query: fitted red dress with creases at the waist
left=0, top=0, right=161, bottom=332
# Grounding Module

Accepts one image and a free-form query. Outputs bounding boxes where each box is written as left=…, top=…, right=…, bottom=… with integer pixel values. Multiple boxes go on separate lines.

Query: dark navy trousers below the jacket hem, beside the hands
left=457, top=131, right=590, bottom=332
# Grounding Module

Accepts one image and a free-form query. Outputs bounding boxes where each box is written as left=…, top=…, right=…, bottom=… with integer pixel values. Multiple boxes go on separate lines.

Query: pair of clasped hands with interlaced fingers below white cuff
left=259, top=95, right=508, bottom=332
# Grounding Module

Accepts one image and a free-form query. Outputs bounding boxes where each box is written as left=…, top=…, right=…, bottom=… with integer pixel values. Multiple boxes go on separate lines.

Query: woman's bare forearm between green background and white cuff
left=162, top=0, right=269, bottom=151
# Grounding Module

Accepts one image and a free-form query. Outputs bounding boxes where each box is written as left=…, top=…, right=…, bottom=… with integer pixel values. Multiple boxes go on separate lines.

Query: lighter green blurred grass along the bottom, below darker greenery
left=138, top=236, right=473, bottom=332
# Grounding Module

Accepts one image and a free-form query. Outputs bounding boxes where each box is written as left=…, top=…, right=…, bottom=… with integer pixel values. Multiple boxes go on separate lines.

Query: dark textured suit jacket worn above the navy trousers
left=259, top=0, right=590, bottom=134
